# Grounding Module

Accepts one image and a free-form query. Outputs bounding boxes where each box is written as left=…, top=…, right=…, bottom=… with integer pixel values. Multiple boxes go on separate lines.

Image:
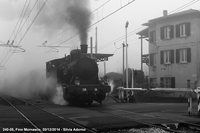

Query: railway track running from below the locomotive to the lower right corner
left=83, top=107, right=200, bottom=133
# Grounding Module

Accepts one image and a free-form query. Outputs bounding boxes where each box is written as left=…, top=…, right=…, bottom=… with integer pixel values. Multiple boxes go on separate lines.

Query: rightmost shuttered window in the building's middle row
left=176, top=48, right=191, bottom=63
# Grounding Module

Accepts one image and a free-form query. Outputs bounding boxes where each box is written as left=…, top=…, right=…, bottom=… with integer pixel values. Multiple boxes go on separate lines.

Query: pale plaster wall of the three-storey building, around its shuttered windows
left=149, top=16, right=200, bottom=88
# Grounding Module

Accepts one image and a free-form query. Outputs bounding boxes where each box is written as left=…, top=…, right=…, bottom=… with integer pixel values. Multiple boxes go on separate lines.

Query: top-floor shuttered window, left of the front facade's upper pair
left=160, top=25, right=174, bottom=40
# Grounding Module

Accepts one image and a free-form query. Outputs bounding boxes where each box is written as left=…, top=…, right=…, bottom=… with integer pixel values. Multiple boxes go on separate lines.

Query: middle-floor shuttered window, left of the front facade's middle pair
left=160, top=50, right=174, bottom=64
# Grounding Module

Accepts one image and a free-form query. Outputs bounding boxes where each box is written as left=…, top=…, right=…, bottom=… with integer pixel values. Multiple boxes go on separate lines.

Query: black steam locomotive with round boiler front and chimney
left=46, top=45, right=110, bottom=105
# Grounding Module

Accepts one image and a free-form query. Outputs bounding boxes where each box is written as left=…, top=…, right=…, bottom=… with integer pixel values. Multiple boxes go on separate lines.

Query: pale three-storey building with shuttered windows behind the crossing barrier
left=137, top=9, right=200, bottom=88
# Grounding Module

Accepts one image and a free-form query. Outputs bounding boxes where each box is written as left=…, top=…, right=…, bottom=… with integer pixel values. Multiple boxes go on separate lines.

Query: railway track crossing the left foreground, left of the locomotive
left=0, top=95, right=97, bottom=133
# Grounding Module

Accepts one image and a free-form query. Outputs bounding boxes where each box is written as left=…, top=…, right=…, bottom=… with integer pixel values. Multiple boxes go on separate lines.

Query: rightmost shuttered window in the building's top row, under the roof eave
left=176, top=22, right=191, bottom=37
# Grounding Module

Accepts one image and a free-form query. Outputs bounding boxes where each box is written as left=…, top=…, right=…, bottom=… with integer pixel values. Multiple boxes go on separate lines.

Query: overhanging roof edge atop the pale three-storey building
left=143, top=9, right=200, bottom=26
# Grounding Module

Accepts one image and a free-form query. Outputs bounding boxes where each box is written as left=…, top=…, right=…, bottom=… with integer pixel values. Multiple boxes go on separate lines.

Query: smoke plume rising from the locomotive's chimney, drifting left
left=35, top=0, right=91, bottom=43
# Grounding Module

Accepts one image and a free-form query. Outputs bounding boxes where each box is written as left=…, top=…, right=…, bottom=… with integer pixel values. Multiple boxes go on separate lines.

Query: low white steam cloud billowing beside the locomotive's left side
left=0, top=70, right=66, bottom=105
